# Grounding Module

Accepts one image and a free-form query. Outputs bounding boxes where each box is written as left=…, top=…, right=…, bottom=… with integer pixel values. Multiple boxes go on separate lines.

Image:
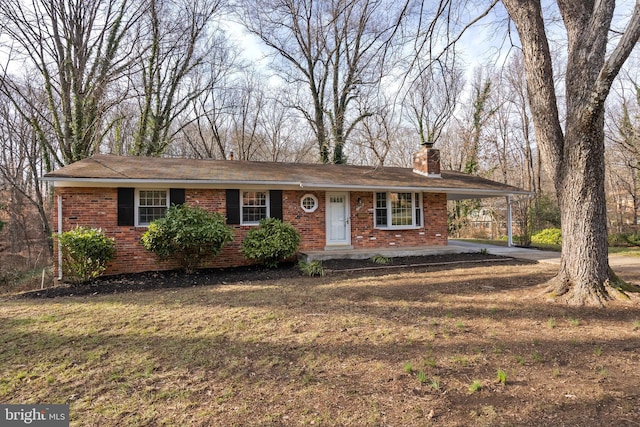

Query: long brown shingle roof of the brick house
left=44, top=154, right=528, bottom=199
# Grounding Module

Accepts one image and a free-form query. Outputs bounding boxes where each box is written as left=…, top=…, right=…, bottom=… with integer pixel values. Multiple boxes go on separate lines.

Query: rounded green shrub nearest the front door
left=242, top=218, right=300, bottom=268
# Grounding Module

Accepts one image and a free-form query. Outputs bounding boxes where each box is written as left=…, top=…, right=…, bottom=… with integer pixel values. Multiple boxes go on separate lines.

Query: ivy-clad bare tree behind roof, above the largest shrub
left=131, top=0, right=224, bottom=156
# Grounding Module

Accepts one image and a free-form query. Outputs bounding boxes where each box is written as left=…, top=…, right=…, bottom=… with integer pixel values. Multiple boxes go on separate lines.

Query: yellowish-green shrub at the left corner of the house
left=57, top=227, right=116, bottom=283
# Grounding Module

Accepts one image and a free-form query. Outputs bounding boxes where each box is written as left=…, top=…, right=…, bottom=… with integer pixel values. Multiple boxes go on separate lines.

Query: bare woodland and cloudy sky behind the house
left=0, top=0, right=640, bottom=304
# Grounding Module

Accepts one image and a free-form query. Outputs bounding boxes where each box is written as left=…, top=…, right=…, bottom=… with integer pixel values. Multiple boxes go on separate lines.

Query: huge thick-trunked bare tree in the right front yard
left=502, top=0, right=640, bottom=305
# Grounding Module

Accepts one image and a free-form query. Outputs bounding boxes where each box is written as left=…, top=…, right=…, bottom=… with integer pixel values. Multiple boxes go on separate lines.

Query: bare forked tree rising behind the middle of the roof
left=242, top=0, right=407, bottom=163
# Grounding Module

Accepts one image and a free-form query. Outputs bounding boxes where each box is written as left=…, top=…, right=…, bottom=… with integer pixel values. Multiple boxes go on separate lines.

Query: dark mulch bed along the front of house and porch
left=17, top=253, right=527, bottom=298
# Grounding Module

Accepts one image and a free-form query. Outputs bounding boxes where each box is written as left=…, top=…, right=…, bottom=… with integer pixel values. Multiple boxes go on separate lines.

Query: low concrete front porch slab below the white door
left=298, top=243, right=478, bottom=262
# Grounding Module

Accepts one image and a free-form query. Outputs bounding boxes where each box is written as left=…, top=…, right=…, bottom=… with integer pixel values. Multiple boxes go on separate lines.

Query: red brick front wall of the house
left=54, top=187, right=447, bottom=274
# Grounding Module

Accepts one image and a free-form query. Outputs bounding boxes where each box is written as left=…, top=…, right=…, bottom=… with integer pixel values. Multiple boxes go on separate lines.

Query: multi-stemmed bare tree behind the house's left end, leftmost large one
left=0, top=0, right=140, bottom=169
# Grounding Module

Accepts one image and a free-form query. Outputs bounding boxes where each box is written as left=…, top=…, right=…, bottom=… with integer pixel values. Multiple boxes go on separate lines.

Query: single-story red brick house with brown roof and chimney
left=43, top=148, right=528, bottom=277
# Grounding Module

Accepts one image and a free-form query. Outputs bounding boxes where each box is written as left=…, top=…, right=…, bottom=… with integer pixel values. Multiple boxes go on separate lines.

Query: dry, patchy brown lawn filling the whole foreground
left=0, top=265, right=640, bottom=426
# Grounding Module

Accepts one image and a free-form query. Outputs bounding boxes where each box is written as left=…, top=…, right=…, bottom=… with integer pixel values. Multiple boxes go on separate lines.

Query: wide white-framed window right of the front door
left=374, top=191, right=422, bottom=229
